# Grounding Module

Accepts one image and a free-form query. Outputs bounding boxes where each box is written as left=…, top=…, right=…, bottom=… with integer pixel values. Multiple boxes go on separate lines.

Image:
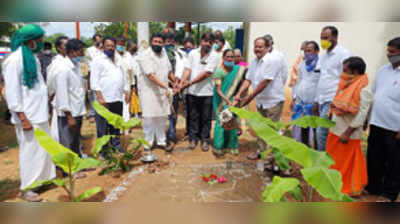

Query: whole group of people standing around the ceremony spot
left=3, top=24, right=400, bottom=201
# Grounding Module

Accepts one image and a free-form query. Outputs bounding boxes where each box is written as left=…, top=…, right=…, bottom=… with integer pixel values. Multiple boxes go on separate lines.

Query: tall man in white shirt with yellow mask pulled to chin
left=314, top=26, right=351, bottom=151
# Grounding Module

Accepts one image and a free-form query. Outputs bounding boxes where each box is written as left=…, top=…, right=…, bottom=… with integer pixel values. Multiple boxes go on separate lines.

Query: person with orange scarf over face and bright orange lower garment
left=326, top=57, right=373, bottom=196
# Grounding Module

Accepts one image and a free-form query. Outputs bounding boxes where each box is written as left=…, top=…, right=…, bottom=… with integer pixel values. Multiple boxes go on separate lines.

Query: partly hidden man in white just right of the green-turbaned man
left=47, top=36, right=68, bottom=142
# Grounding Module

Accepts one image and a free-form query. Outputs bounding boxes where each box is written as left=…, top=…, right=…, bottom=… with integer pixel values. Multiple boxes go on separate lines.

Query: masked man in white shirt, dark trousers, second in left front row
left=55, top=39, right=86, bottom=157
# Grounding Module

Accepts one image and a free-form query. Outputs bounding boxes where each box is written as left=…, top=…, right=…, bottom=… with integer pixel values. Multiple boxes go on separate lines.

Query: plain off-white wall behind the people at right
left=247, top=22, right=400, bottom=82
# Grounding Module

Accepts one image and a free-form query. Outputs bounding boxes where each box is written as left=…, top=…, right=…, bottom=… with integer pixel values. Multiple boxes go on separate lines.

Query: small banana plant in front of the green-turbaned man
left=24, top=129, right=101, bottom=202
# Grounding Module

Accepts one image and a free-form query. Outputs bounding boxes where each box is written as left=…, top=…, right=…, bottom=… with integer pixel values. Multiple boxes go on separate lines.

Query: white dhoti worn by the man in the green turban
left=15, top=122, right=56, bottom=190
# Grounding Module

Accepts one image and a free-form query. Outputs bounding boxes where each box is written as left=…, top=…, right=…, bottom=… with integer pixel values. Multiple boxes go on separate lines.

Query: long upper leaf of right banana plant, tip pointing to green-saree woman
left=230, top=108, right=312, bottom=167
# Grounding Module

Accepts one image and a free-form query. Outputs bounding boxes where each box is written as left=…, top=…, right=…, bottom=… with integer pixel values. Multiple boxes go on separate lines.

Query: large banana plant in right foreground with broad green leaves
left=230, top=107, right=354, bottom=202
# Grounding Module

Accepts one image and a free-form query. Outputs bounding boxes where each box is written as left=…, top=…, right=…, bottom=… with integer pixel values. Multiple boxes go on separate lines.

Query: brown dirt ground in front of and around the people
left=0, top=89, right=388, bottom=202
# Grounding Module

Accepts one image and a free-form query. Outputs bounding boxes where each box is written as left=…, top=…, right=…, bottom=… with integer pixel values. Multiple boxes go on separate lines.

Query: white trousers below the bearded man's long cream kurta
left=143, top=117, right=168, bottom=146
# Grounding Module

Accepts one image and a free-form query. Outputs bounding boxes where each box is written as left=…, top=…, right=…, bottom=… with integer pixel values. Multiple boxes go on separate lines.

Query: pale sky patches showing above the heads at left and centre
left=43, top=22, right=242, bottom=37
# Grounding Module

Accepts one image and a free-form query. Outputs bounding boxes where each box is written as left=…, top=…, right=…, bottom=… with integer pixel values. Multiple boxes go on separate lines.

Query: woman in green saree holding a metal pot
left=213, top=49, right=246, bottom=157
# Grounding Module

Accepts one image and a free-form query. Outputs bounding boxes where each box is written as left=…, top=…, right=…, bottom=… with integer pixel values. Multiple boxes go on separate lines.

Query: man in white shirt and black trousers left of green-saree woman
left=180, top=32, right=220, bottom=152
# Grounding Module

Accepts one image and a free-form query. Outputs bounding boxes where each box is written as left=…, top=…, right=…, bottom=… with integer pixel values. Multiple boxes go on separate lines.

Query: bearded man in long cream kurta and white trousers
left=138, top=33, right=175, bottom=152
